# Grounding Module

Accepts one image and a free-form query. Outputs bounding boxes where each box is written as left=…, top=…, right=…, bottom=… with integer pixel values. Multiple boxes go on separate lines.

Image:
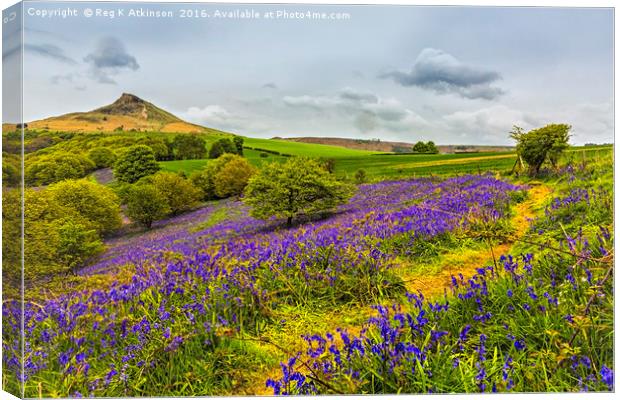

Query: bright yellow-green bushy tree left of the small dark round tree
left=46, top=179, right=122, bottom=234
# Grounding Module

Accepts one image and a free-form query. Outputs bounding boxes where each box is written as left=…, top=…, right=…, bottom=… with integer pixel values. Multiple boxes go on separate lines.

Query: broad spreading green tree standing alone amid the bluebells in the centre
left=244, top=157, right=354, bottom=226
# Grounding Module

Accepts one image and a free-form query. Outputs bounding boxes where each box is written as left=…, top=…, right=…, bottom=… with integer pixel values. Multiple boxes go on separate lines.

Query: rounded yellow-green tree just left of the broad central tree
left=213, top=155, right=256, bottom=198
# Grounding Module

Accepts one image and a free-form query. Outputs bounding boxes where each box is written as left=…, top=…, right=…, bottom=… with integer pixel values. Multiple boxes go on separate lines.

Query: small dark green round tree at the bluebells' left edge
left=125, top=184, right=170, bottom=229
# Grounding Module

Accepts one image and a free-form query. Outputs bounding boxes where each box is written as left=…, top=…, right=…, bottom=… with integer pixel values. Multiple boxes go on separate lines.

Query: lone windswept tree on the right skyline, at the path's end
left=510, top=124, right=571, bottom=176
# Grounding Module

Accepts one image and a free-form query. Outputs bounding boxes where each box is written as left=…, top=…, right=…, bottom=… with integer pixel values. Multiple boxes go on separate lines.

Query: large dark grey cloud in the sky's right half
left=379, top=48, right=504, bottom=100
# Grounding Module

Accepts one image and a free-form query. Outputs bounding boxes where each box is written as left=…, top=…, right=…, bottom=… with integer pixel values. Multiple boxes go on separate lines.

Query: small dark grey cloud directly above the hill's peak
left=84, top=37, right=140, bottom=84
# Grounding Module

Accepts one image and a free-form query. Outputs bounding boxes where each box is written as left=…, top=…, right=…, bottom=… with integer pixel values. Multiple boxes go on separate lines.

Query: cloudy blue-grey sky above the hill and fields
left=3, top=3, right=614, bottom=144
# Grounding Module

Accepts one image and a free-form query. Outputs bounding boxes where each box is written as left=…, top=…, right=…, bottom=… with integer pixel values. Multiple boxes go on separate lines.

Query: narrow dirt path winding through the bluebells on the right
left=403, top=185, right=552, bottom=298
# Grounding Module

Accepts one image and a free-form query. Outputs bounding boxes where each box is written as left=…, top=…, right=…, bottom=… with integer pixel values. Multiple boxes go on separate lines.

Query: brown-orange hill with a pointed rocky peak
left=28, top=93, right=225, bottom=133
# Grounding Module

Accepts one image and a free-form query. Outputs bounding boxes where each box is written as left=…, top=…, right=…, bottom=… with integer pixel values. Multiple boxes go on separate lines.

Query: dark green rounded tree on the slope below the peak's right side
left=114, top=145, right=159, bottom=183
